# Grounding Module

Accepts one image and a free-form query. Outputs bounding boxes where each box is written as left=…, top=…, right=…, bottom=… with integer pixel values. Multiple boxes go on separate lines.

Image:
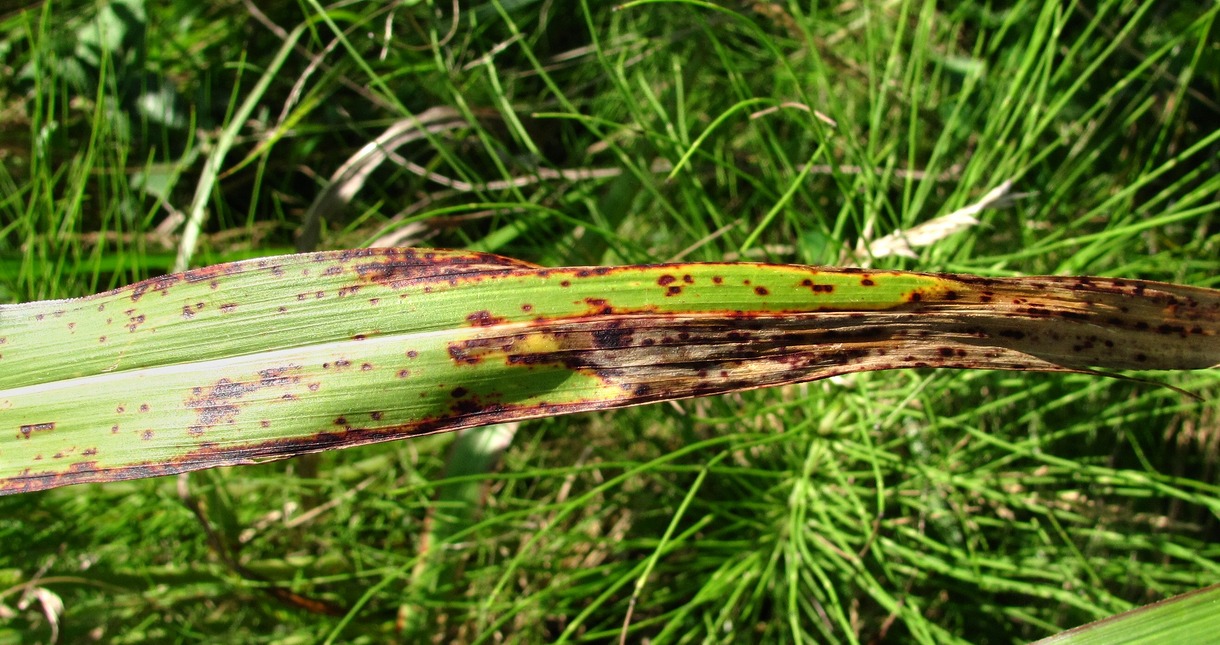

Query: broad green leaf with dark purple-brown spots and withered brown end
left=0, top=249, right=1220, bottom=494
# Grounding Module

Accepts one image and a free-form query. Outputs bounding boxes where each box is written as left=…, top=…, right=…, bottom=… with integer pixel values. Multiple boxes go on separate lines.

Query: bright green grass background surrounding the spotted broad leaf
left=0, top=0, right=1220, bottom=643
